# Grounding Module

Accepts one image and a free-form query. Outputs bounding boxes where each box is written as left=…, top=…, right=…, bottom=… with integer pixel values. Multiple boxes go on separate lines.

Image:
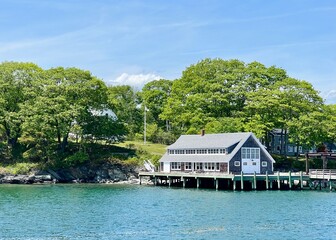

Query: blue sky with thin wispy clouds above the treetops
left=0, top=0, right=336, bottom=103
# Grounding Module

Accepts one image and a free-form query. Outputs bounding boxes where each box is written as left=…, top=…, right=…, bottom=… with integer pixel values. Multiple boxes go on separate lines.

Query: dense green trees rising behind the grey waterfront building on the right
left=141, top=59, right=336, bottom=154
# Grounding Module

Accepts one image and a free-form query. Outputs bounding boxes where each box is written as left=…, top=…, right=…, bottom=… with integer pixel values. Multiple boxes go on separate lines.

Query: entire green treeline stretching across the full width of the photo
left=0, top=59, right=336, bottom=167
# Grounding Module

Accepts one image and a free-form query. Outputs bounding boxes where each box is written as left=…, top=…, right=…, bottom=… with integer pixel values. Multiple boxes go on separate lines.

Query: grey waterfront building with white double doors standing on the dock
left=160, top=130, right=275, bottom=173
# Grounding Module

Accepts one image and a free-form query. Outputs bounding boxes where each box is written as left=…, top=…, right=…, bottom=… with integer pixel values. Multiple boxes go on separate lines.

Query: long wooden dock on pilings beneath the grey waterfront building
left=139, top=169, right=336, bottom=191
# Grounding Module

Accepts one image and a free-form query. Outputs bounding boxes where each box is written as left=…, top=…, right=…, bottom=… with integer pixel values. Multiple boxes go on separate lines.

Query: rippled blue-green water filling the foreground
left=0, top=184, right=336, bottom=239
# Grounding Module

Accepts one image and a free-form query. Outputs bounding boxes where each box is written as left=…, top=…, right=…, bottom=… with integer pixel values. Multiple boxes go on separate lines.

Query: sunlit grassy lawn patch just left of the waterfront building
left=114, top=141, right=167, bottom=156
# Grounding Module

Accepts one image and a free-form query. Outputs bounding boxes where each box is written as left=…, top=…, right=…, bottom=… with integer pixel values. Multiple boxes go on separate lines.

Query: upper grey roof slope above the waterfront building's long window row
left=167, top=132, right=252, bottom=149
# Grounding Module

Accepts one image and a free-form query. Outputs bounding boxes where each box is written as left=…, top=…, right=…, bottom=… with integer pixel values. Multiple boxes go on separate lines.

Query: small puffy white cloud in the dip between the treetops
left=109, top=73, right=163, bottom=89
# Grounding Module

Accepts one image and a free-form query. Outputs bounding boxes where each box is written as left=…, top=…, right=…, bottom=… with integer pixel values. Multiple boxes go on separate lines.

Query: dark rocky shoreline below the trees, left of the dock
left=0, top=163, right=152, bottom=184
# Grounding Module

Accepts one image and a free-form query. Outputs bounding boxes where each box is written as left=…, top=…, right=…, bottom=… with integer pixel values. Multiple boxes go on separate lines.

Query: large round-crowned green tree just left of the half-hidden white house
left=20, top=67, right=107, bottom=156
